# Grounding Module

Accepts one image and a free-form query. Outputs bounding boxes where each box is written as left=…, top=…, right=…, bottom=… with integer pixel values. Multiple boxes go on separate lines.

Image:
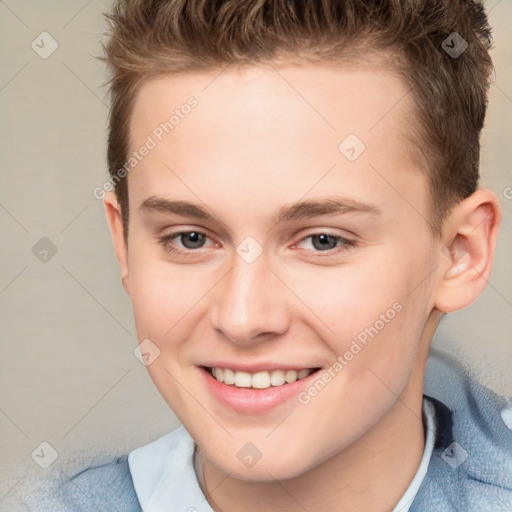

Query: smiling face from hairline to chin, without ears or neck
left=115, top=64, right=436, bottom=480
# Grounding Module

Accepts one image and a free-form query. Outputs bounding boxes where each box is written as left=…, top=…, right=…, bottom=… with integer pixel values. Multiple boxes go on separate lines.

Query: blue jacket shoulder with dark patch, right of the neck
left=411, top=350, right=512, bottom=512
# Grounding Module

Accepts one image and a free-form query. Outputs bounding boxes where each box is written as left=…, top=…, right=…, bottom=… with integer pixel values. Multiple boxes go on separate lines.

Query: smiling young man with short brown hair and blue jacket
left=25, top=0, right=512, bottom=512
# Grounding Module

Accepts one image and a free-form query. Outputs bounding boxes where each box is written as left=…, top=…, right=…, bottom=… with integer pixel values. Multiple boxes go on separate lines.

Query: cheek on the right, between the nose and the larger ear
left=300, top=251, right=428, bottom=384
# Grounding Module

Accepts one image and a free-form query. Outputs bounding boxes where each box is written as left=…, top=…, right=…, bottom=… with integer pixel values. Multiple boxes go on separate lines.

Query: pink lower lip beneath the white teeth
left=199, top=368, right=318, bottom=414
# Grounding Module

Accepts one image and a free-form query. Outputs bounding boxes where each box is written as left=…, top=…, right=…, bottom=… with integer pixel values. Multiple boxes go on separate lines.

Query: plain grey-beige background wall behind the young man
left=0, top=0, right=512, bottom=508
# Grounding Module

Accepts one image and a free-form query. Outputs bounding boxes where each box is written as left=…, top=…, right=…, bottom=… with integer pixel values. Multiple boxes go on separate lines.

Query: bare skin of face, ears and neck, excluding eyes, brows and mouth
left=104, top=63, right=500, bottom=512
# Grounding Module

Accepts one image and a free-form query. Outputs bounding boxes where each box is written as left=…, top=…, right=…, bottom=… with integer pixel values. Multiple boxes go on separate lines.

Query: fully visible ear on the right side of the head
left=434, top=189, right=501, bottom=313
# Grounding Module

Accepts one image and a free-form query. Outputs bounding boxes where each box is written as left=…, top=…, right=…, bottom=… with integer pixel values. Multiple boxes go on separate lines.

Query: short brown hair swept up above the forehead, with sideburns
left=101, top=0, right=493, bottom=238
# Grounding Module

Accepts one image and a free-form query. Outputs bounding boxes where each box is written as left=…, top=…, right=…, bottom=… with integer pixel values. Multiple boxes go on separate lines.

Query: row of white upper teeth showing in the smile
left=207, top=368, right=313, bottom=389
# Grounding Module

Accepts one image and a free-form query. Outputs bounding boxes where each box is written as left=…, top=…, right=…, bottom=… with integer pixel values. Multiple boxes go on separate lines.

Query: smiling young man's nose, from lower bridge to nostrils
left=210, top=250, right=293, bottom=345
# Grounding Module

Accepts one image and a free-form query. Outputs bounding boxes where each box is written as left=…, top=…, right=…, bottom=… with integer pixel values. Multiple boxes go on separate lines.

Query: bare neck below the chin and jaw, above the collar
left=198, top=364, right=425, bottom=512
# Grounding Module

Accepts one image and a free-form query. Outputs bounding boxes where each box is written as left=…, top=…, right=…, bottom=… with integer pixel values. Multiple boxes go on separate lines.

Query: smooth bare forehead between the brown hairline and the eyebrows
left=129, top=64, right=426, bottom=231
